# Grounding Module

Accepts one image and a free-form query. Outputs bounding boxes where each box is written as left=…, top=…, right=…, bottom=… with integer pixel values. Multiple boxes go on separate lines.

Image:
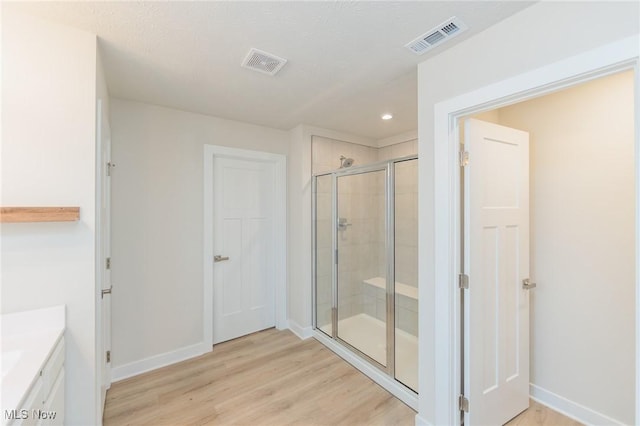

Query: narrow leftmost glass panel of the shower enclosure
left=315, top=175, right=333, bottom=336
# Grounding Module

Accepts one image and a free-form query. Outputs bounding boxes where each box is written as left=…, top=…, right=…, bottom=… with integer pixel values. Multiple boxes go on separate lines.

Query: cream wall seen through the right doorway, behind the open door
left=498, top=71, right=635, bottom=424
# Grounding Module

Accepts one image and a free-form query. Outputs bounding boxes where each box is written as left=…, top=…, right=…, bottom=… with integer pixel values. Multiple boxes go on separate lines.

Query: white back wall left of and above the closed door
left=110, top=99, right=290, bottom=375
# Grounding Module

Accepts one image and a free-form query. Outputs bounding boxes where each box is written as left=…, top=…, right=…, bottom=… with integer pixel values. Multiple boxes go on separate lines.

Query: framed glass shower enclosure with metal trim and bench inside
left=313, top=156, right=418, bottom=393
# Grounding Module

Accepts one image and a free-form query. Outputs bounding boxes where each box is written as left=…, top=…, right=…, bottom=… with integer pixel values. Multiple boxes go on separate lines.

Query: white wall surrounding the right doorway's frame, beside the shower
left=418, top=2, right=639, bottom=423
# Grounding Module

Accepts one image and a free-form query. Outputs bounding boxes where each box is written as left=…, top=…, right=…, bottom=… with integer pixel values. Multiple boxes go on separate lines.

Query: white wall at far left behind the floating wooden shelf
left=0, top=7, right=99, bottom=425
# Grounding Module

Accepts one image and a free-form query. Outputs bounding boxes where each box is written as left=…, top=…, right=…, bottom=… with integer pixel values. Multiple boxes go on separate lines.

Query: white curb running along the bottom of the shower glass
left=313, top=330, right=418, bottom=411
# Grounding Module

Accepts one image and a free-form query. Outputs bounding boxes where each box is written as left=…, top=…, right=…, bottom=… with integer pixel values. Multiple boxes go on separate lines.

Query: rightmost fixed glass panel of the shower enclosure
left=394, top=160, right=418, bottom=392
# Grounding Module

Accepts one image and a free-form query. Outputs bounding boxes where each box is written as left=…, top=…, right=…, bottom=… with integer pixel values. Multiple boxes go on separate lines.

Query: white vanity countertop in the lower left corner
left=0, top=305, right=65, bottom=423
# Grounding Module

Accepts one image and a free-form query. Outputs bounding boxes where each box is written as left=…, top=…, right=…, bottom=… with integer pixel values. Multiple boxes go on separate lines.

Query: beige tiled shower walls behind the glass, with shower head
left=312, top=136, right=418, bottom=335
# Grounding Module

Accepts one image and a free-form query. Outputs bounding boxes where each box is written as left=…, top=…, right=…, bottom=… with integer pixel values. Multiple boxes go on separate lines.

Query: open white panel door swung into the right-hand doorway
left=464, top=120, right=529, bottom=425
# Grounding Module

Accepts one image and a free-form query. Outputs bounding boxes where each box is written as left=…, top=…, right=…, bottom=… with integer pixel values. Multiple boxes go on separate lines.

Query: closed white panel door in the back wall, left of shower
left=211, top=157, right=275, bottom=344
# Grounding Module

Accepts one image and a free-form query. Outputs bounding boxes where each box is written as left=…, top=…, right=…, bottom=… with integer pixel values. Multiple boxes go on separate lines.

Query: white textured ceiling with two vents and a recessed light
left=5, top=1, right=532, bottom=139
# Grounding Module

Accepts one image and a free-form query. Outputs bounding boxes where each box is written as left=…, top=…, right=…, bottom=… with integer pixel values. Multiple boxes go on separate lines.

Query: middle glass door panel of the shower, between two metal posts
left=337, top=170, right=387, bottom=366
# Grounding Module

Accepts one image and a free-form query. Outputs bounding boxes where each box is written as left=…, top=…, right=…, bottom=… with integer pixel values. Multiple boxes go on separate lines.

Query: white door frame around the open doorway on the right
left=430, top=36, right=640, bottom=425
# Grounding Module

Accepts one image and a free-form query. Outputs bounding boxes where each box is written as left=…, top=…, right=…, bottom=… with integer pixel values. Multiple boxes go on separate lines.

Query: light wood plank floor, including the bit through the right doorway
left=104, top=329, right=580, bottom=426
